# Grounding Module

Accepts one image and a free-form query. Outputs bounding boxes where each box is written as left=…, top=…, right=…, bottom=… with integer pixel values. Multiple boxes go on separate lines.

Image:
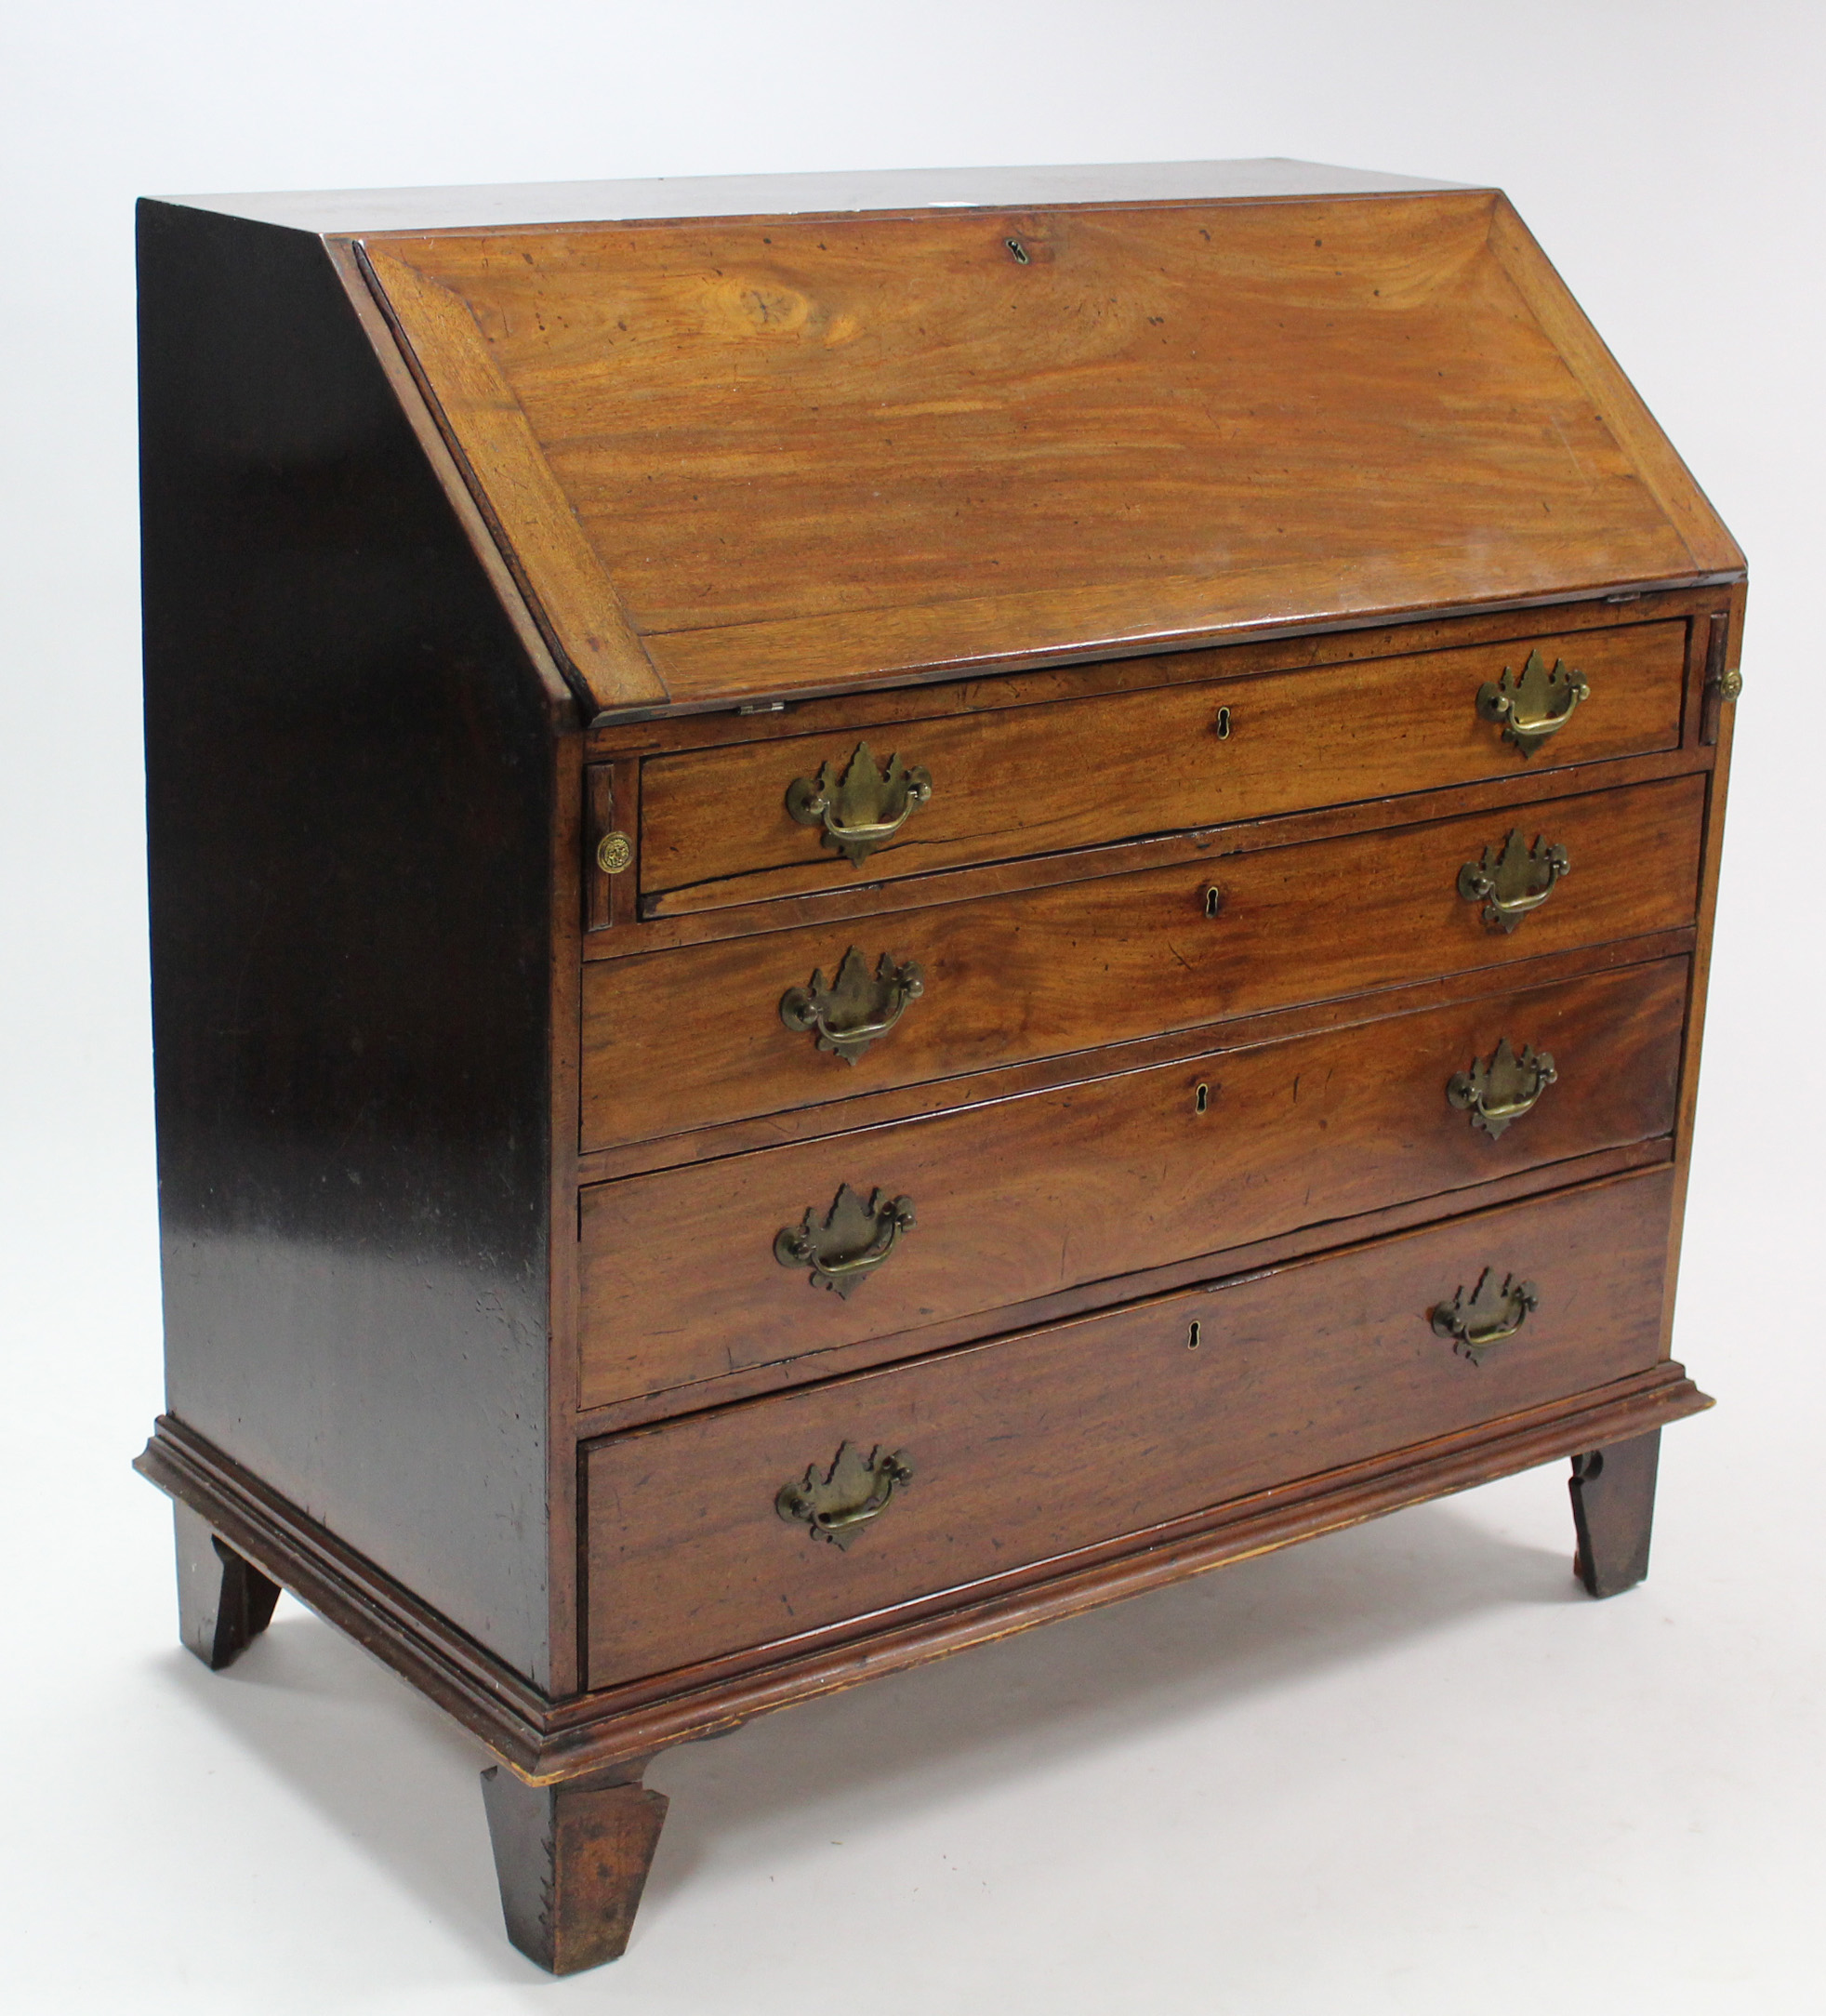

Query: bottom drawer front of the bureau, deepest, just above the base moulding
left=587, top=1172, right=1673, bottom=1688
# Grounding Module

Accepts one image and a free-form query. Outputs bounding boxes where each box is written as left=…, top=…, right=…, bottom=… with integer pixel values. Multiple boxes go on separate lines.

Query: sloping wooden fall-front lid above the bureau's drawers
left=369, top=192, right=1703, bottom=708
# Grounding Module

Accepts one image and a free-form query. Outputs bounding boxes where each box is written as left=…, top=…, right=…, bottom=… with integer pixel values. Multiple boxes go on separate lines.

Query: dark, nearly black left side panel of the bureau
left=141, top=204, right=568, bottom=1681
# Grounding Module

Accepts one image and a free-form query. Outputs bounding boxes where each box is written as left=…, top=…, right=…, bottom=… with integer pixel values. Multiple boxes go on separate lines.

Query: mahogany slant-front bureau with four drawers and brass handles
left=139, top=161, right=1743, bottom=1971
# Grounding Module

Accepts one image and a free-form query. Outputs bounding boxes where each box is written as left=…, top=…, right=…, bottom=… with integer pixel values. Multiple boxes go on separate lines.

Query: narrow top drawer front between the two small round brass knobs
left=641, top=621, right=1687, bottom=913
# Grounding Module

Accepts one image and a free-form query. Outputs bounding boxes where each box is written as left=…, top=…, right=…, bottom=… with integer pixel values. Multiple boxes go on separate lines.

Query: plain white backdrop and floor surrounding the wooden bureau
left=0, top=0, right=1826, bottom=2016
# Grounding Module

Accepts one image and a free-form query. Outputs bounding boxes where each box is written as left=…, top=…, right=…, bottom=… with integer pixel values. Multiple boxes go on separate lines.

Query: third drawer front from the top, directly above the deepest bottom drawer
left=580, top=960, right=1687, bottom=1407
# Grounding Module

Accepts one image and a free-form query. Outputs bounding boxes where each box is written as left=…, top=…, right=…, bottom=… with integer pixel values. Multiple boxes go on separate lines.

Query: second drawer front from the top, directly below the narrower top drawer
left=582, top=776, right=1705, bottom=1149
